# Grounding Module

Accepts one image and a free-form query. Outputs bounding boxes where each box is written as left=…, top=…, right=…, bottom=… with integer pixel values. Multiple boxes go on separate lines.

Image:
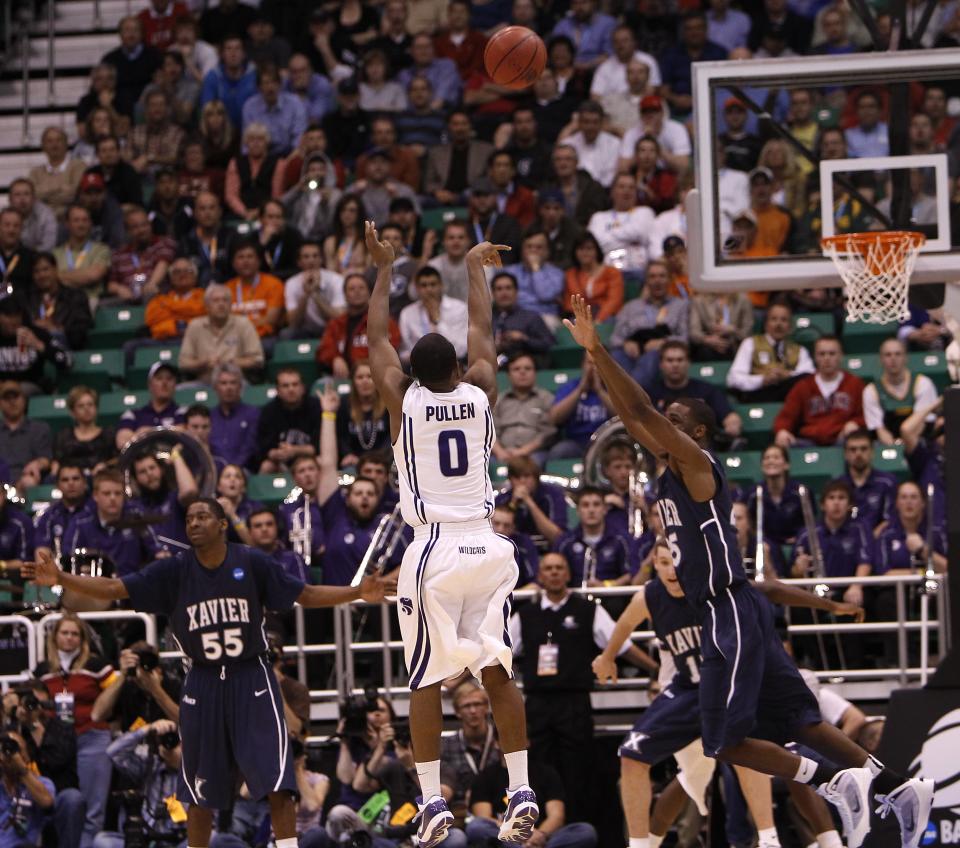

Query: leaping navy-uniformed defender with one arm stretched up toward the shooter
left=564, top=296, right=933, bottom=848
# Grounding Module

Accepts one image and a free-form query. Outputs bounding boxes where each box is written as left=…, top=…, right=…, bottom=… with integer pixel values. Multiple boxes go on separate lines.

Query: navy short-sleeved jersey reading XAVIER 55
left=122, top=545, right=304, bottom=665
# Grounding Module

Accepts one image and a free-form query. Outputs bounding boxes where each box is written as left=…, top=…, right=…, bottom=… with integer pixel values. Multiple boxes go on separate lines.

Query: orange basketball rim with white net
left=820, top=231, right=926, bottom=324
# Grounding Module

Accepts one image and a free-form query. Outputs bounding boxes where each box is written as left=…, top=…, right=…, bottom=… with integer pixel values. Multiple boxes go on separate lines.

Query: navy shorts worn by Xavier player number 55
left=177, top=659, right=297, bottom=810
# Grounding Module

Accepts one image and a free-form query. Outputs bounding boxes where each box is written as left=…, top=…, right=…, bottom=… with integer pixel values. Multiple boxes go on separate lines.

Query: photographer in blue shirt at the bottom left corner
left=0, top=732, right=56, bottom=848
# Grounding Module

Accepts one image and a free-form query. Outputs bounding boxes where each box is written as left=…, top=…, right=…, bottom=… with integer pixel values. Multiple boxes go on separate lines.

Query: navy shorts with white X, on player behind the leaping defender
left=618, top=681, right=700, bottom=766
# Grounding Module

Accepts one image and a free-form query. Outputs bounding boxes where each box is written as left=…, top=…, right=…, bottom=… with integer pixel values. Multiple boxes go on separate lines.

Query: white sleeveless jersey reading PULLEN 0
left=393, top=382, right=494, bottom=527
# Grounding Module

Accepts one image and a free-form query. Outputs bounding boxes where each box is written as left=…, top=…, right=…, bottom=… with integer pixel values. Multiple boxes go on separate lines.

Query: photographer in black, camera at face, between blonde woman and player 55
left=91, top=641, right=180, bottom=732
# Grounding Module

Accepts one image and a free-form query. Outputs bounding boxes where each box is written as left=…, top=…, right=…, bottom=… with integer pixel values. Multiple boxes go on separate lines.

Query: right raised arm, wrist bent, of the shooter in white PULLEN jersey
left=464, top=241, right=510, bottom=406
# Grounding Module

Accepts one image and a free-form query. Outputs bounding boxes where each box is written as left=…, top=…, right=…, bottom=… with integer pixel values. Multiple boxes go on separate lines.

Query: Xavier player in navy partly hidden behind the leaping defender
left=593, top=537, right=863, bottom=845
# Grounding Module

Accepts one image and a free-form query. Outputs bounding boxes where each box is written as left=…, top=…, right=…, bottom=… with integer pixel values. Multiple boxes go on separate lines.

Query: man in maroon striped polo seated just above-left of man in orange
left=107, top=206, right=177, bottom=303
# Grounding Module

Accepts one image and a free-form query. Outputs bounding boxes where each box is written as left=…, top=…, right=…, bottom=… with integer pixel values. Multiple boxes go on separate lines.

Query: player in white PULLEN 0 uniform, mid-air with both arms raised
left=366, top=221, right=540, bottom=848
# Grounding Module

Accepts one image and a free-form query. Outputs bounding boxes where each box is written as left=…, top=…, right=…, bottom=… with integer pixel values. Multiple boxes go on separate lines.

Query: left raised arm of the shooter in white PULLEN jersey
left=364, top=221, right=410, bottom=442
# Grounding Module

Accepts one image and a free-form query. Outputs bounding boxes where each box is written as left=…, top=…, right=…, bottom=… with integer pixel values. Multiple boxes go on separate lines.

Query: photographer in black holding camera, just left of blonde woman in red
left=4, top=680, right=87, bottom=848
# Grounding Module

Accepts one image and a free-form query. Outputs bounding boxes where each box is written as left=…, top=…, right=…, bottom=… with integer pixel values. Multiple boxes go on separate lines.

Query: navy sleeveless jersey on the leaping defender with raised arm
left=657, top=451, right=747, bottom=612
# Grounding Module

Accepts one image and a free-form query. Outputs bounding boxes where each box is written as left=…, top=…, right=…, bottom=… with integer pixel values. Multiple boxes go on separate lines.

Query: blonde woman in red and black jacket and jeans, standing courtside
left=33, top=612, right=117, bottom=846
